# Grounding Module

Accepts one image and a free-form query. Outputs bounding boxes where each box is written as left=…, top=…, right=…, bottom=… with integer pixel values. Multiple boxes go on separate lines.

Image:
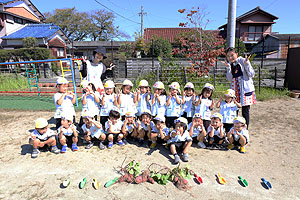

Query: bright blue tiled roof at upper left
left=2, top=24, right=60, bottom=39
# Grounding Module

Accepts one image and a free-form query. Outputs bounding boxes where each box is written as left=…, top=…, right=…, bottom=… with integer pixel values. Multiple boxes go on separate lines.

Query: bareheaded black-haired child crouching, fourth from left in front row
left=105, top=110, right=125, bottom=149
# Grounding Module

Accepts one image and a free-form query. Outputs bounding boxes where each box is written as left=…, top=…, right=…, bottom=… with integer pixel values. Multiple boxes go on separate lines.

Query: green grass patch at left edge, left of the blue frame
left=0, top=74, right=29, bottom=91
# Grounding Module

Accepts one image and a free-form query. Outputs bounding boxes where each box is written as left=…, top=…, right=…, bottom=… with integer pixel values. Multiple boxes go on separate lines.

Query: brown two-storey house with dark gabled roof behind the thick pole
left=218, top=6, right=278, bottom=49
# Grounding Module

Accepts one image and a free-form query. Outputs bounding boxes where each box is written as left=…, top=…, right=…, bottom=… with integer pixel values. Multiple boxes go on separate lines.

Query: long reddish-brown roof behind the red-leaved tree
left=144, top=28, right=219, bottom=43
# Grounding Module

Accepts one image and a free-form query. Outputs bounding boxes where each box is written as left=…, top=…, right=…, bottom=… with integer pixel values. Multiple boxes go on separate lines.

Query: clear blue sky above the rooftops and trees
left=31, top=0, right=300, bottom=40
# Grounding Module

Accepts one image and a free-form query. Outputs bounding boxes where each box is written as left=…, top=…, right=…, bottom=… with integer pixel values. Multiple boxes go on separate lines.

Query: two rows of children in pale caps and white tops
left=30, top=78, right=249, bottom=163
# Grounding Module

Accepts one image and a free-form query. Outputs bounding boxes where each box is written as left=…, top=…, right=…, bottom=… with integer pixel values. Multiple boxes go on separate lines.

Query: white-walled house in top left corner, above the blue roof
left=0, top=0, right=45, bottom=43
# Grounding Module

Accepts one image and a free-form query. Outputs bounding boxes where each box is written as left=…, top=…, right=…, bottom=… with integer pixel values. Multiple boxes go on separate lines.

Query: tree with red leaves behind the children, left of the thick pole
left=173, top=7, right=225, bottom=76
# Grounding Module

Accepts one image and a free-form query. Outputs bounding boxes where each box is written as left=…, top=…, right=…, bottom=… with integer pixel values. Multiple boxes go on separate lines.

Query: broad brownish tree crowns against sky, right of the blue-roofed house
left=45, top=7, right=129, bottom=41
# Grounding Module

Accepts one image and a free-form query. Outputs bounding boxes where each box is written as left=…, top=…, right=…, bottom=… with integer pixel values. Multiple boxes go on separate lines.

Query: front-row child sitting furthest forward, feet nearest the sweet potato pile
left=168, top=117, right=192, bottom=164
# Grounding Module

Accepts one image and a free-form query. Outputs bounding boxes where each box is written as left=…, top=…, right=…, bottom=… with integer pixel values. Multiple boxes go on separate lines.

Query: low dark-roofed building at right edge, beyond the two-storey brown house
left=252, top=34, right=300, bottom=58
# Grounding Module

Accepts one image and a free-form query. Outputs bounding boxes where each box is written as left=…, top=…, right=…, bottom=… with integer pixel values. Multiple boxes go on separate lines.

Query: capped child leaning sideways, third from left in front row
left=81, top=113, right=106, bottom=150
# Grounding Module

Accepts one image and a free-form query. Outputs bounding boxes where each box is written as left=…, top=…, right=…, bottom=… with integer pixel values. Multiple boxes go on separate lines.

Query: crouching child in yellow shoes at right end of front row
left=227, top=117, right=250, bottom=153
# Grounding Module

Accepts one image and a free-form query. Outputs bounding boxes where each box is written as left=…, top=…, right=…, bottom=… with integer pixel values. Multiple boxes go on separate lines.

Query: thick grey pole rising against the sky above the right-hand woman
left=227, top=0, right=237, bottom=47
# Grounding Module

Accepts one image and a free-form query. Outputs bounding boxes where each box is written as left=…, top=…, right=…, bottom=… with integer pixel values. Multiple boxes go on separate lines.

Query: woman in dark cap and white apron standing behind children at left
left=80, top=46, right=114, bottom=94
